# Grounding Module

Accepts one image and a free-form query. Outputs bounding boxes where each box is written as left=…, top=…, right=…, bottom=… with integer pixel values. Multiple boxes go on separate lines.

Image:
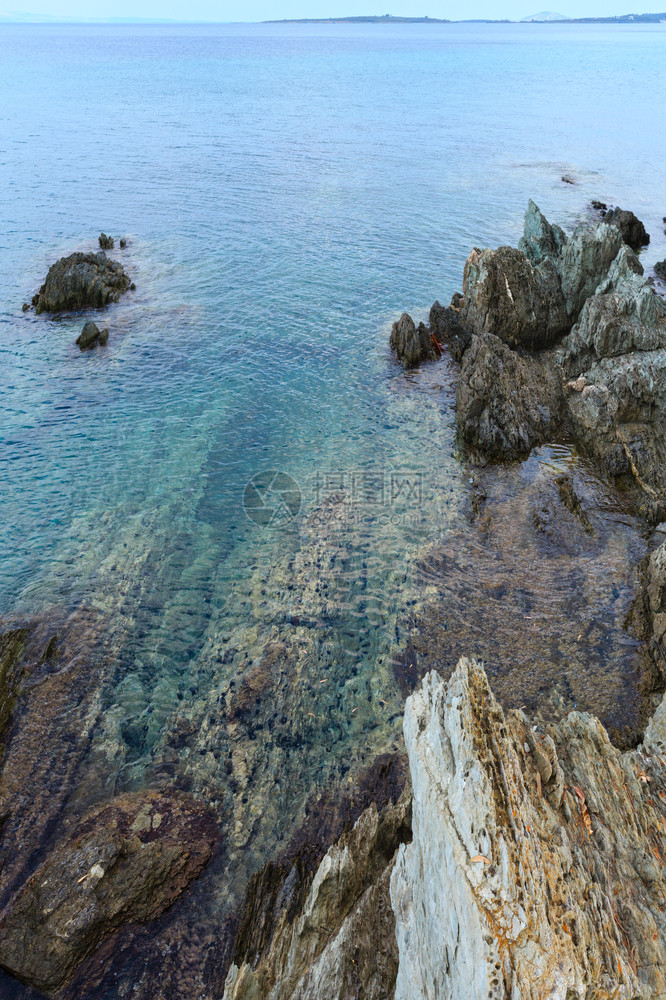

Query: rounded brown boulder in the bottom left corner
left=0, top=791, right=216, bottom=993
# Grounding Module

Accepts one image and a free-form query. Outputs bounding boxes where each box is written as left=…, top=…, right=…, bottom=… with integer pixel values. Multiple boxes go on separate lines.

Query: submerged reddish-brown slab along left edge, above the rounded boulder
left=0, top=609, right=107, bottom=907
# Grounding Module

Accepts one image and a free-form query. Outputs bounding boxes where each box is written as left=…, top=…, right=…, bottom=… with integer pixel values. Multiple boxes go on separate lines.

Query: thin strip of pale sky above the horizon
left=5, top=0, right=666, bottom=21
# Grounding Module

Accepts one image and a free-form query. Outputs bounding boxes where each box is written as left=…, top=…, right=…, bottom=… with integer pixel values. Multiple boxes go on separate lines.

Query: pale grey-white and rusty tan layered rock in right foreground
left=391, top=659, right=666, bottom=1000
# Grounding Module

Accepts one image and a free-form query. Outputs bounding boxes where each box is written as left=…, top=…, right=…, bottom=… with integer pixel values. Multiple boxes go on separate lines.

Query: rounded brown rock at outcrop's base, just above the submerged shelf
left=456, top=334, right=564, bottom=458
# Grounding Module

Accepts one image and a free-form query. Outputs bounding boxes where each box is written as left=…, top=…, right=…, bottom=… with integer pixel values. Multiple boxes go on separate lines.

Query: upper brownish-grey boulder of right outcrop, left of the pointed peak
left=463, top=247, right=571, bottom=350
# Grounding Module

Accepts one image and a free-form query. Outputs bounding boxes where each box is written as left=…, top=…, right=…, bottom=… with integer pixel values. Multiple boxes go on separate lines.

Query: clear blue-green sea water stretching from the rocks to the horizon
left=0, top=19, right=666, bottom=996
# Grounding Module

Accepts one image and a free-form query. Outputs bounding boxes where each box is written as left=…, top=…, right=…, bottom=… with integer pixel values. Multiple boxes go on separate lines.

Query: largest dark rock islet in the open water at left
left=33, top=251, right=130, bottom=313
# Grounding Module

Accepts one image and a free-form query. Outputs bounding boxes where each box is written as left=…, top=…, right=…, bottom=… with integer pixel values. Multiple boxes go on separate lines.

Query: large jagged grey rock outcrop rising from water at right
left=448, top=202, right=666, bottom=492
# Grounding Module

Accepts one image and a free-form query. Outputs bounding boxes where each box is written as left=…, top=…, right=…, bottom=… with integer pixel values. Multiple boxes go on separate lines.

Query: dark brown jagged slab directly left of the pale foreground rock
left=224, top=756, right=411, bottom=1000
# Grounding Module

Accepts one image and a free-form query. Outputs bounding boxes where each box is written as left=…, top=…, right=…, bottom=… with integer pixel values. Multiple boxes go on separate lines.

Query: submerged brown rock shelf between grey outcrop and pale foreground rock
left=394, top=448, right=652, bottom=748
